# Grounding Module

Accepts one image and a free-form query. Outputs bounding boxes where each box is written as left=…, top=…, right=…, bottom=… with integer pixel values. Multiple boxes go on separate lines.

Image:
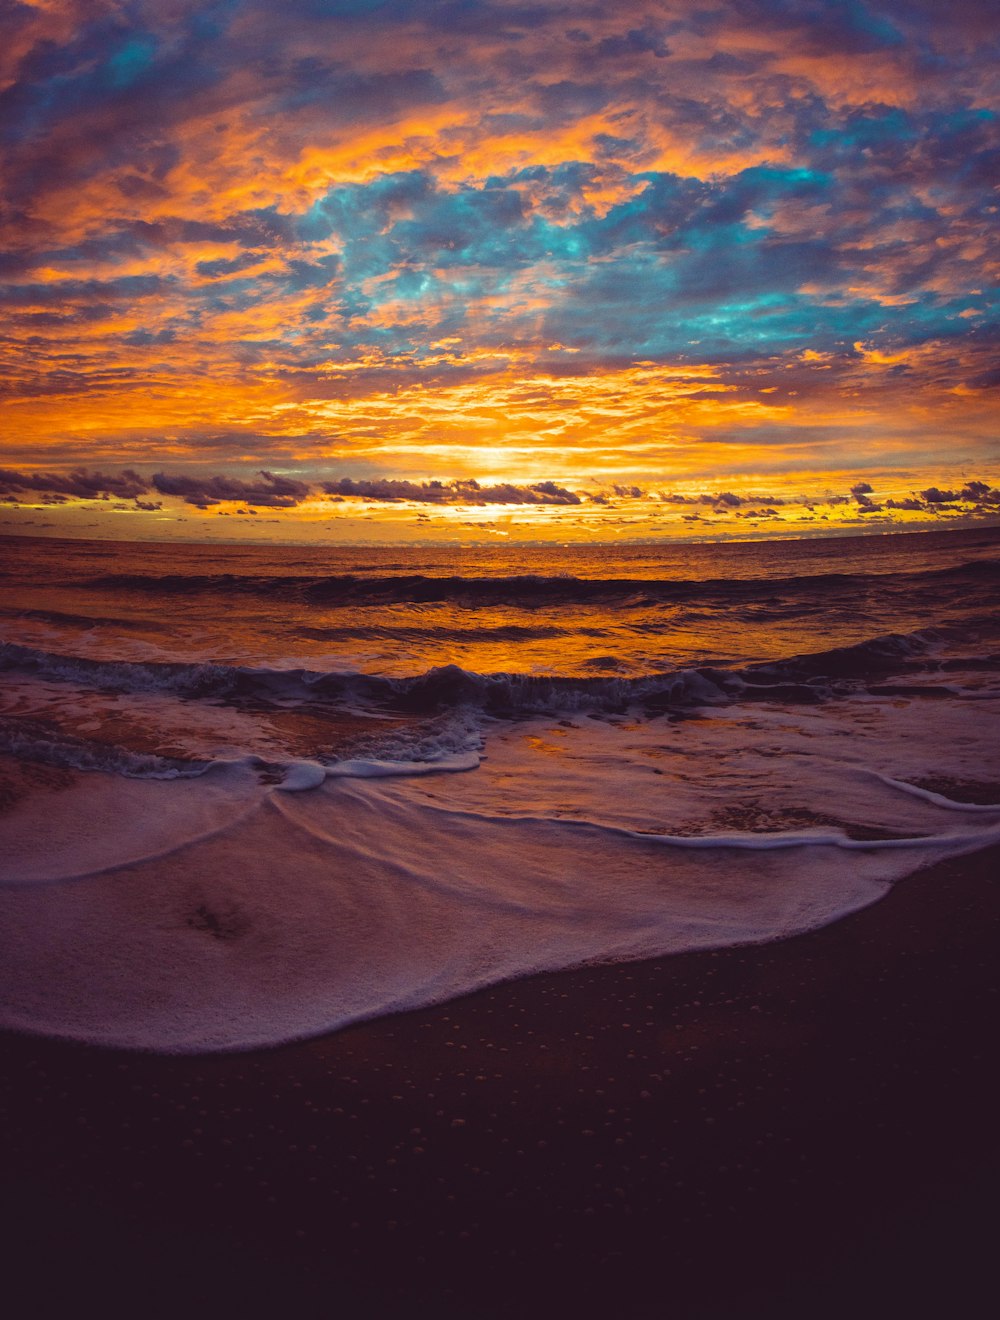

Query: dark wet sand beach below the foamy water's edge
left=0, top=850, right=1000, bottom=1320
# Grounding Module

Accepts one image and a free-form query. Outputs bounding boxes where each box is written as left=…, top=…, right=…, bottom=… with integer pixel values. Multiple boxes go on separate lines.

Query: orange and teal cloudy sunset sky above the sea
left=0, top=0, right=1000, bottom=541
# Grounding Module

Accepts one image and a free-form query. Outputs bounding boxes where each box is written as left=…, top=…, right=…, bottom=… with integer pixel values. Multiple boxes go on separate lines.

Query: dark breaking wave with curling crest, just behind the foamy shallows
left=0, top=630, right=995, bottom=717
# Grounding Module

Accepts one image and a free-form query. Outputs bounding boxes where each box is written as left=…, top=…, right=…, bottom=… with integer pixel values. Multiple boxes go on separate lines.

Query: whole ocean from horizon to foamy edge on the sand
left=0, top=528, right=1000, bottom=1052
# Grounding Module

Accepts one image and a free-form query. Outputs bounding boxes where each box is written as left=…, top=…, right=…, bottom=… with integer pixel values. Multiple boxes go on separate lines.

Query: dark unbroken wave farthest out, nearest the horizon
left=74, top=560, right=1000, bottom=609
